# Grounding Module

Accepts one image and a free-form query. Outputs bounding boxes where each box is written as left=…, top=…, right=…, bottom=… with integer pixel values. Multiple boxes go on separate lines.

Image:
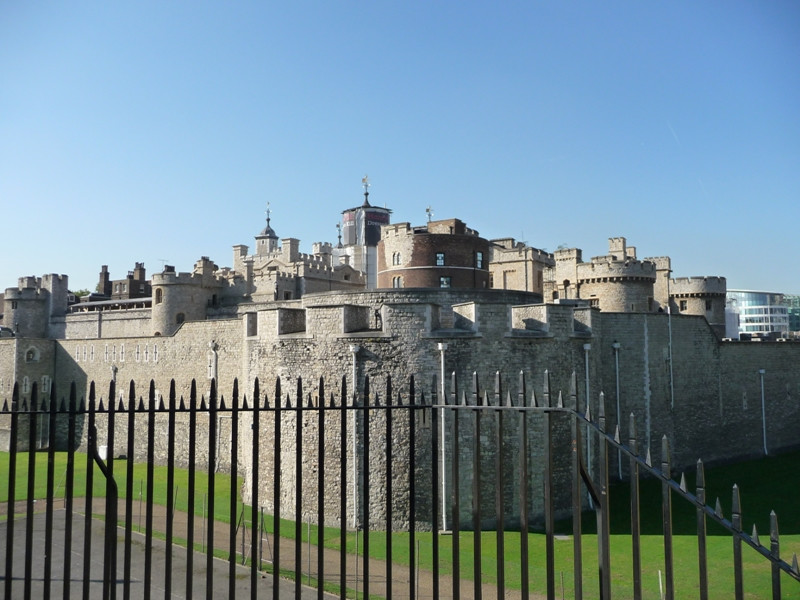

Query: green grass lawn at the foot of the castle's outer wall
left=0, top=452, right=800, bottom=599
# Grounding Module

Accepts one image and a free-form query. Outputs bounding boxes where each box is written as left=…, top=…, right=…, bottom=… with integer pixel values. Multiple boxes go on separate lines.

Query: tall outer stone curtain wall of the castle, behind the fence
left=0, top=290, right=800, bottom=521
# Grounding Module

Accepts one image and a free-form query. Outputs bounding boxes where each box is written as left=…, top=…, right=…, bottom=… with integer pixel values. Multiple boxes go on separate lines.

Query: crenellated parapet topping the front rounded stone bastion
left=242, top=290, right=599, bottom=347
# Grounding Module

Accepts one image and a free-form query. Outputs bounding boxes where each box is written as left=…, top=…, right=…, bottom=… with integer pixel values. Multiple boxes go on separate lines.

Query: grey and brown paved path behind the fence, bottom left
left=0, top=498, right=535, bottom=600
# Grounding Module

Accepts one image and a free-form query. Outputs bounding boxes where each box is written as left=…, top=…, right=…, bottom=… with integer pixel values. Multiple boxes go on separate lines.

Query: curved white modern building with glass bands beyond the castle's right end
left=726, top=290, right=789, bottom=338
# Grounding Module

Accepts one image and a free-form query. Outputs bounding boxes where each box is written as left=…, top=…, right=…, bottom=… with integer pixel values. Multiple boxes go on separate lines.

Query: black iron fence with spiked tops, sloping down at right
left=0, top=374, right=800, bottom=599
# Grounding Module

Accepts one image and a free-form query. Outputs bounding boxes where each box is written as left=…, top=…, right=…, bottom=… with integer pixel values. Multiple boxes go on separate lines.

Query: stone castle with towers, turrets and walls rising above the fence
left=0, top=187, right=800, bottom=524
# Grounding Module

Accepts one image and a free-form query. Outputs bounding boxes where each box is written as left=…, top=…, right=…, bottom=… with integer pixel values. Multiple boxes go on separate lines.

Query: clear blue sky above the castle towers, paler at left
left=0, top=0, right=800, bottom=293
